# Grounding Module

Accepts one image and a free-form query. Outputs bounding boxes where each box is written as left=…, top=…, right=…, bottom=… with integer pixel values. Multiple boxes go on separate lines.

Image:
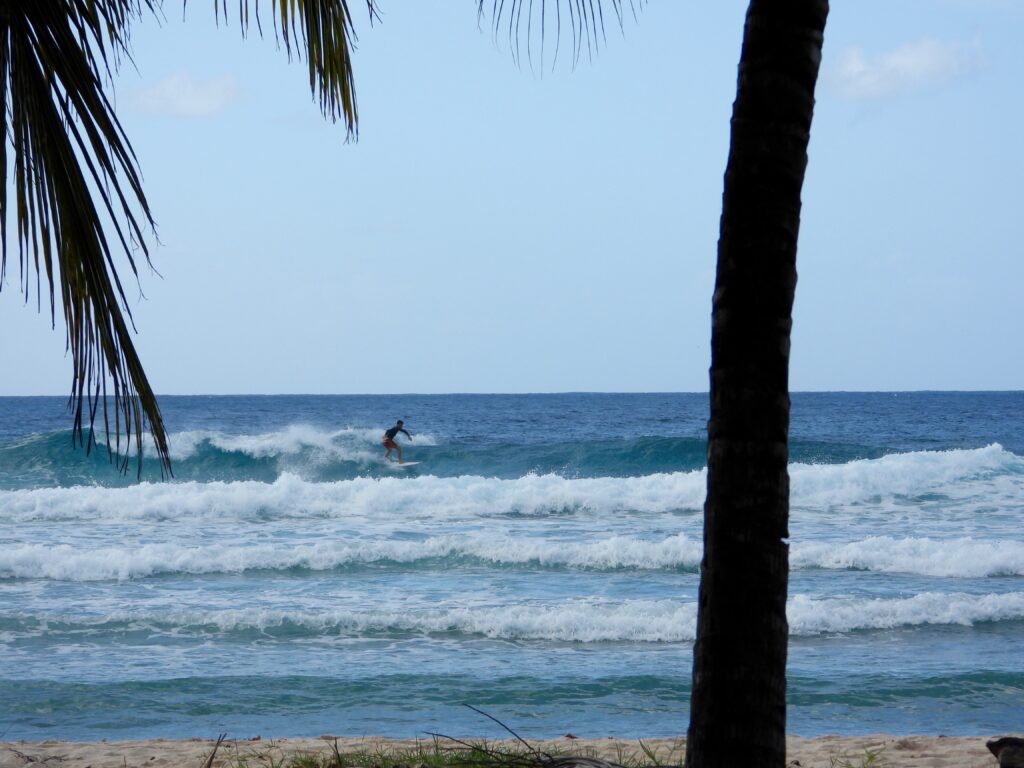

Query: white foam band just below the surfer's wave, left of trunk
left=0, top=472, right=703, bottom=522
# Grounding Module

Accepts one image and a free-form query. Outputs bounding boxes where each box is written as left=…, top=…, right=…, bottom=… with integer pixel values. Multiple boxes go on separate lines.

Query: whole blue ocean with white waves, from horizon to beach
left=0, top=392, right=1024, bottom=740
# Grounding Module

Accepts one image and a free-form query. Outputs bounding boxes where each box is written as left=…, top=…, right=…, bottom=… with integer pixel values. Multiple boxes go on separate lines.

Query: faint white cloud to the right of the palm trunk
left=829, top=39, right=981, bottom=100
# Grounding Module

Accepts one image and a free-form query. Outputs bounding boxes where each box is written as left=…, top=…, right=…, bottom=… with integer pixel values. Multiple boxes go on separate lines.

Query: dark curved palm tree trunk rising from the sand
left=686, top=0, right=828, bottom=768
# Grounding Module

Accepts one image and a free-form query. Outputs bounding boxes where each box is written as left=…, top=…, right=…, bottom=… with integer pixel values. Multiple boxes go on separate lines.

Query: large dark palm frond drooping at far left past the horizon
left=0, top=0, right=170, bottom=474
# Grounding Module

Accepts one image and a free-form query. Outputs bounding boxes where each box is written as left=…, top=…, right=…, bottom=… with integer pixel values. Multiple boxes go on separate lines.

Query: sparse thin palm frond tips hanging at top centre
left=477, top=0, right=646, bottom=70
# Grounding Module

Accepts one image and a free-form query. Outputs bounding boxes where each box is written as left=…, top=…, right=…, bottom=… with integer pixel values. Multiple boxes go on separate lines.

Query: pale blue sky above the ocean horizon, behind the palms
left=0, top=0, right=1024, bottom=395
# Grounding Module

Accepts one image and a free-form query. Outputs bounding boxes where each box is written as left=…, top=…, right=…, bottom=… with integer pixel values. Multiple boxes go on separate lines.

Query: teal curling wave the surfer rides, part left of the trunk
left=0, top=424, right=706, bottom=487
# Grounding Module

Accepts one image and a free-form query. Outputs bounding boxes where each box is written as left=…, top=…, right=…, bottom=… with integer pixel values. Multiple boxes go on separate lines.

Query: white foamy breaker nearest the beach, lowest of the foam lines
left=8, top=592, right=1024, bottom=643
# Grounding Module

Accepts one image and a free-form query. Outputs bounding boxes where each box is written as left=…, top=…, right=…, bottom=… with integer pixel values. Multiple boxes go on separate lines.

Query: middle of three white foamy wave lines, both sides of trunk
left=0, top=532, right=1024, bottom=582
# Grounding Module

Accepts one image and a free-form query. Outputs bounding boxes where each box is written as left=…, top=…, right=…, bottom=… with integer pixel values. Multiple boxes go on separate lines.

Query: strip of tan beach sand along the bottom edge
left=0, top=734, right=1010, bottom=768
